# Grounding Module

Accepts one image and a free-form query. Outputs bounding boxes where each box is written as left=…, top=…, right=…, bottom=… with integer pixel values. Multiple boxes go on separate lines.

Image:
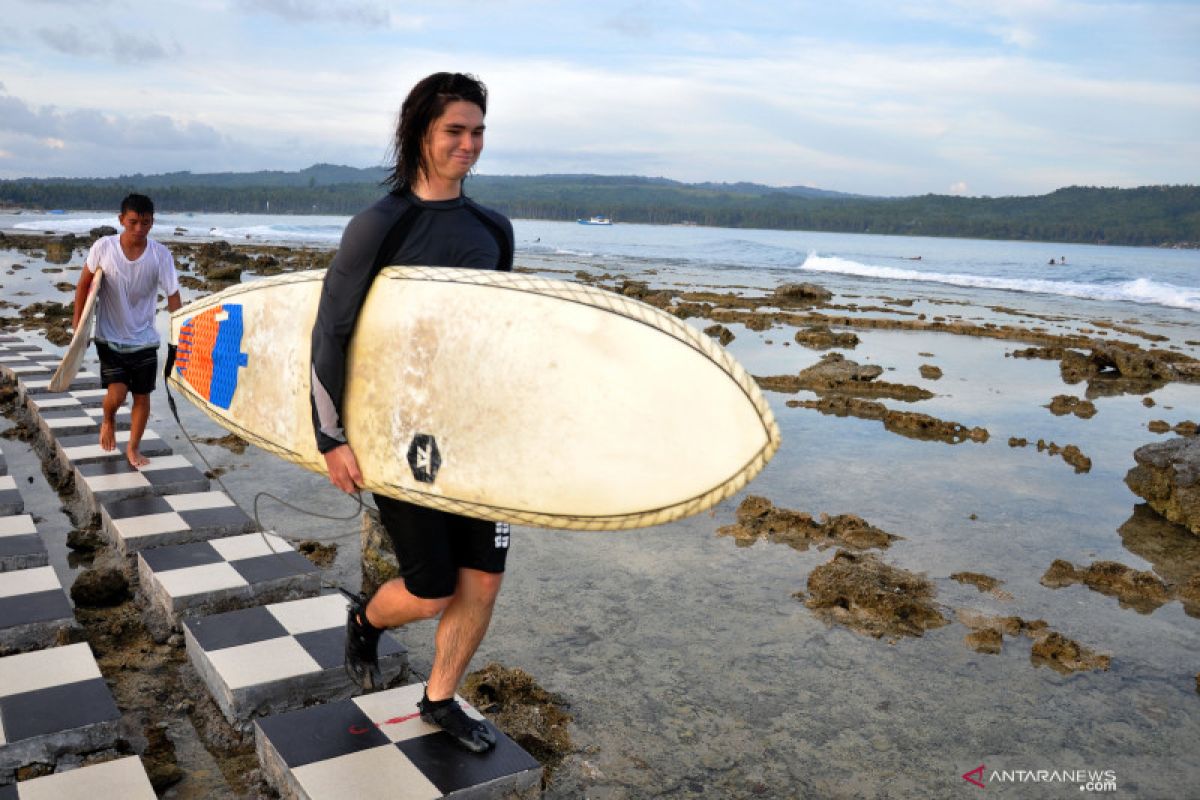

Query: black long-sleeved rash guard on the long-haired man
left=311, top=192, right=514, bottom=453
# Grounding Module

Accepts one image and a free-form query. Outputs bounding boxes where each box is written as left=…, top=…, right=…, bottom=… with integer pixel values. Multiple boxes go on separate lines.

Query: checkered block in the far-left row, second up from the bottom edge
left=0, top=644, right=120, bottom=782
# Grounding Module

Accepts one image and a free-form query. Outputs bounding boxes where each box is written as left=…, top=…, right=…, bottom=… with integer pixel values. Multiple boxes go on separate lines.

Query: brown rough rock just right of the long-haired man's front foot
left=461, top=662, right=574, bottom=786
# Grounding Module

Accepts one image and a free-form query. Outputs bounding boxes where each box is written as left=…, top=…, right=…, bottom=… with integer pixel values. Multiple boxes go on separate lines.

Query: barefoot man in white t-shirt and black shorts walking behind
left=73, top=194, right=182, bottom=467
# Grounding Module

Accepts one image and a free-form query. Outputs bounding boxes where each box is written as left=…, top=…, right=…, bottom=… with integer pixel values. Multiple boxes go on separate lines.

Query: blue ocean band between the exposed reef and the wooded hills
left=9, top=212, right=1200, bottom=312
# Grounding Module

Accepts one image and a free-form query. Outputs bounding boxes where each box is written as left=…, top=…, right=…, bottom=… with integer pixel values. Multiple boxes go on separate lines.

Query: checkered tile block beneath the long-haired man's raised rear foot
left=184, top=595, right=408, bottom=724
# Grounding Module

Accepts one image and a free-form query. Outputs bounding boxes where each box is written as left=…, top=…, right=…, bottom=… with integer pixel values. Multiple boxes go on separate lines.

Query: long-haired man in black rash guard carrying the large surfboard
left=312, top=72, right=514, bottom=752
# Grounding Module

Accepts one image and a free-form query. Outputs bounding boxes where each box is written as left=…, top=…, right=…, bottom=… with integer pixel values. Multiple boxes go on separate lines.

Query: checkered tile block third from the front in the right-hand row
left=138, top=533, right=320, bottom=638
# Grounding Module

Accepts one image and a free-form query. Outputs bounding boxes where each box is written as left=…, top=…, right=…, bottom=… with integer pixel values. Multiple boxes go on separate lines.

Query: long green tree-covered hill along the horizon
left=0, top=164, right=1200, bottom=246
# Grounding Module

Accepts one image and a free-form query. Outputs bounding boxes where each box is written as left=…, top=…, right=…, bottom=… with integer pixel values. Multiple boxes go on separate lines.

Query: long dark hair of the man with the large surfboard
left=384, top=72, right=487, bottom=192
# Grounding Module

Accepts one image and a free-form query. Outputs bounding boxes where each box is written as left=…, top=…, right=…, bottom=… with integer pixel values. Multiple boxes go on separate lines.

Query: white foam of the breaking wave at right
left=800, top=252, right=1200, bottom=311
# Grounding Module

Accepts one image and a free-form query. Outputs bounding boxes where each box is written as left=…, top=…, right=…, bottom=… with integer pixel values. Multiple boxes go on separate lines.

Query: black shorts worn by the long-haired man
left=374, top=494, right=509, bottom=600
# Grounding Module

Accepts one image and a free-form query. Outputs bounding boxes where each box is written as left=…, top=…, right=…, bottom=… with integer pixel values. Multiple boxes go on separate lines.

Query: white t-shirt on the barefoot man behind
left=86, top=234, right=179, bottom=347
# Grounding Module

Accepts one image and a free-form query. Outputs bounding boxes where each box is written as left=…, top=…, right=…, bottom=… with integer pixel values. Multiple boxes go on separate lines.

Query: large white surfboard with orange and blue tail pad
left=169, top=266, right=780, bottom=530
